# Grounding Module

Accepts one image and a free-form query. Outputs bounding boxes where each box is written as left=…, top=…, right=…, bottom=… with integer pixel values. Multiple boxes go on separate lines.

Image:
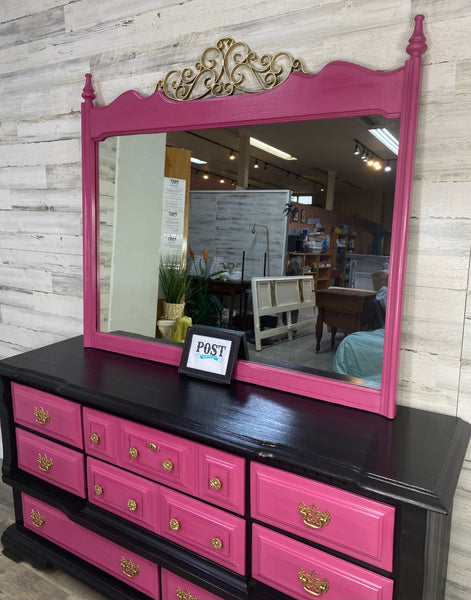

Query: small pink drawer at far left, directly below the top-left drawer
left=16, top=427, right=85, bottom=498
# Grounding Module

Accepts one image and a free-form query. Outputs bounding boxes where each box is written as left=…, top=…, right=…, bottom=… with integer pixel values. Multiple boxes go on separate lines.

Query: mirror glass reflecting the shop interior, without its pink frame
left=99, top=116, right=399, bottom=387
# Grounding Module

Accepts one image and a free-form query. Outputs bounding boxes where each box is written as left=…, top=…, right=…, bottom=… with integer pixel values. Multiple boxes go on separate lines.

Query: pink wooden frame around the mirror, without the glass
left=82, top=15, right=427, bottom=418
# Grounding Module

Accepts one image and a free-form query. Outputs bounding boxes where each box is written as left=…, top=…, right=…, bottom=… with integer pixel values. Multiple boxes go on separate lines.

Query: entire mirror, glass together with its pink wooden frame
left=83, top=19, right=430, bottom=417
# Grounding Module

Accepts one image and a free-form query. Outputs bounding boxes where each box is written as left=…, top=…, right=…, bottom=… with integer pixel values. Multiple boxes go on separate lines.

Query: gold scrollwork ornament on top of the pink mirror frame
left=155, top=37, right=306, bottom=100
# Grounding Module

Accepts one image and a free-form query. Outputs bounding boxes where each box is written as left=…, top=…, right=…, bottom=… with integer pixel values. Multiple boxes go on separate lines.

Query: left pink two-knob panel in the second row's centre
left=87, top=458, right=159, bottom=531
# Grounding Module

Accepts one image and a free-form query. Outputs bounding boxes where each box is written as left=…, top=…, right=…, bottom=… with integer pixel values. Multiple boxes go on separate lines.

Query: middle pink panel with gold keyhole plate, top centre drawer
left=119, top=419, right=198, bottom=495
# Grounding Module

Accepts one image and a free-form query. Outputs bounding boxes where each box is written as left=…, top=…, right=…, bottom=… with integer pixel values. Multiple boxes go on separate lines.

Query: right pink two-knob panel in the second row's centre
left=159, top=487, right=245, bottom=575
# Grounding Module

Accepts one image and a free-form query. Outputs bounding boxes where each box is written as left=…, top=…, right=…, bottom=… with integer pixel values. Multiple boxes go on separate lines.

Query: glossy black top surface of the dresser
left=0, top=336, right=471, bottom=512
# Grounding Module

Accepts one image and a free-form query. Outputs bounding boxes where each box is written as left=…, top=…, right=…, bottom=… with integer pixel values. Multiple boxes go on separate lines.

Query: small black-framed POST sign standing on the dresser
left=178, top=325, right=248, bottom=383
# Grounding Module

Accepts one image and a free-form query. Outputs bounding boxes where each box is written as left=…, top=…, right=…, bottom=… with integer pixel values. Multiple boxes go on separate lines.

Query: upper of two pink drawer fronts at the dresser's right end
left=251, top=463, right=395, bottom=571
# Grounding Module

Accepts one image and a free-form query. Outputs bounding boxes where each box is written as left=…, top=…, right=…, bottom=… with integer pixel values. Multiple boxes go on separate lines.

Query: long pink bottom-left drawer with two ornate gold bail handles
left=22, top=494, right=160, bottom=600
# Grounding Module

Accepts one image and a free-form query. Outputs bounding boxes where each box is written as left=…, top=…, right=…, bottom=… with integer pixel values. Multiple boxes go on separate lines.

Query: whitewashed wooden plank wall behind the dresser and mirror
left=0, top=0, right=471, bottom=600
